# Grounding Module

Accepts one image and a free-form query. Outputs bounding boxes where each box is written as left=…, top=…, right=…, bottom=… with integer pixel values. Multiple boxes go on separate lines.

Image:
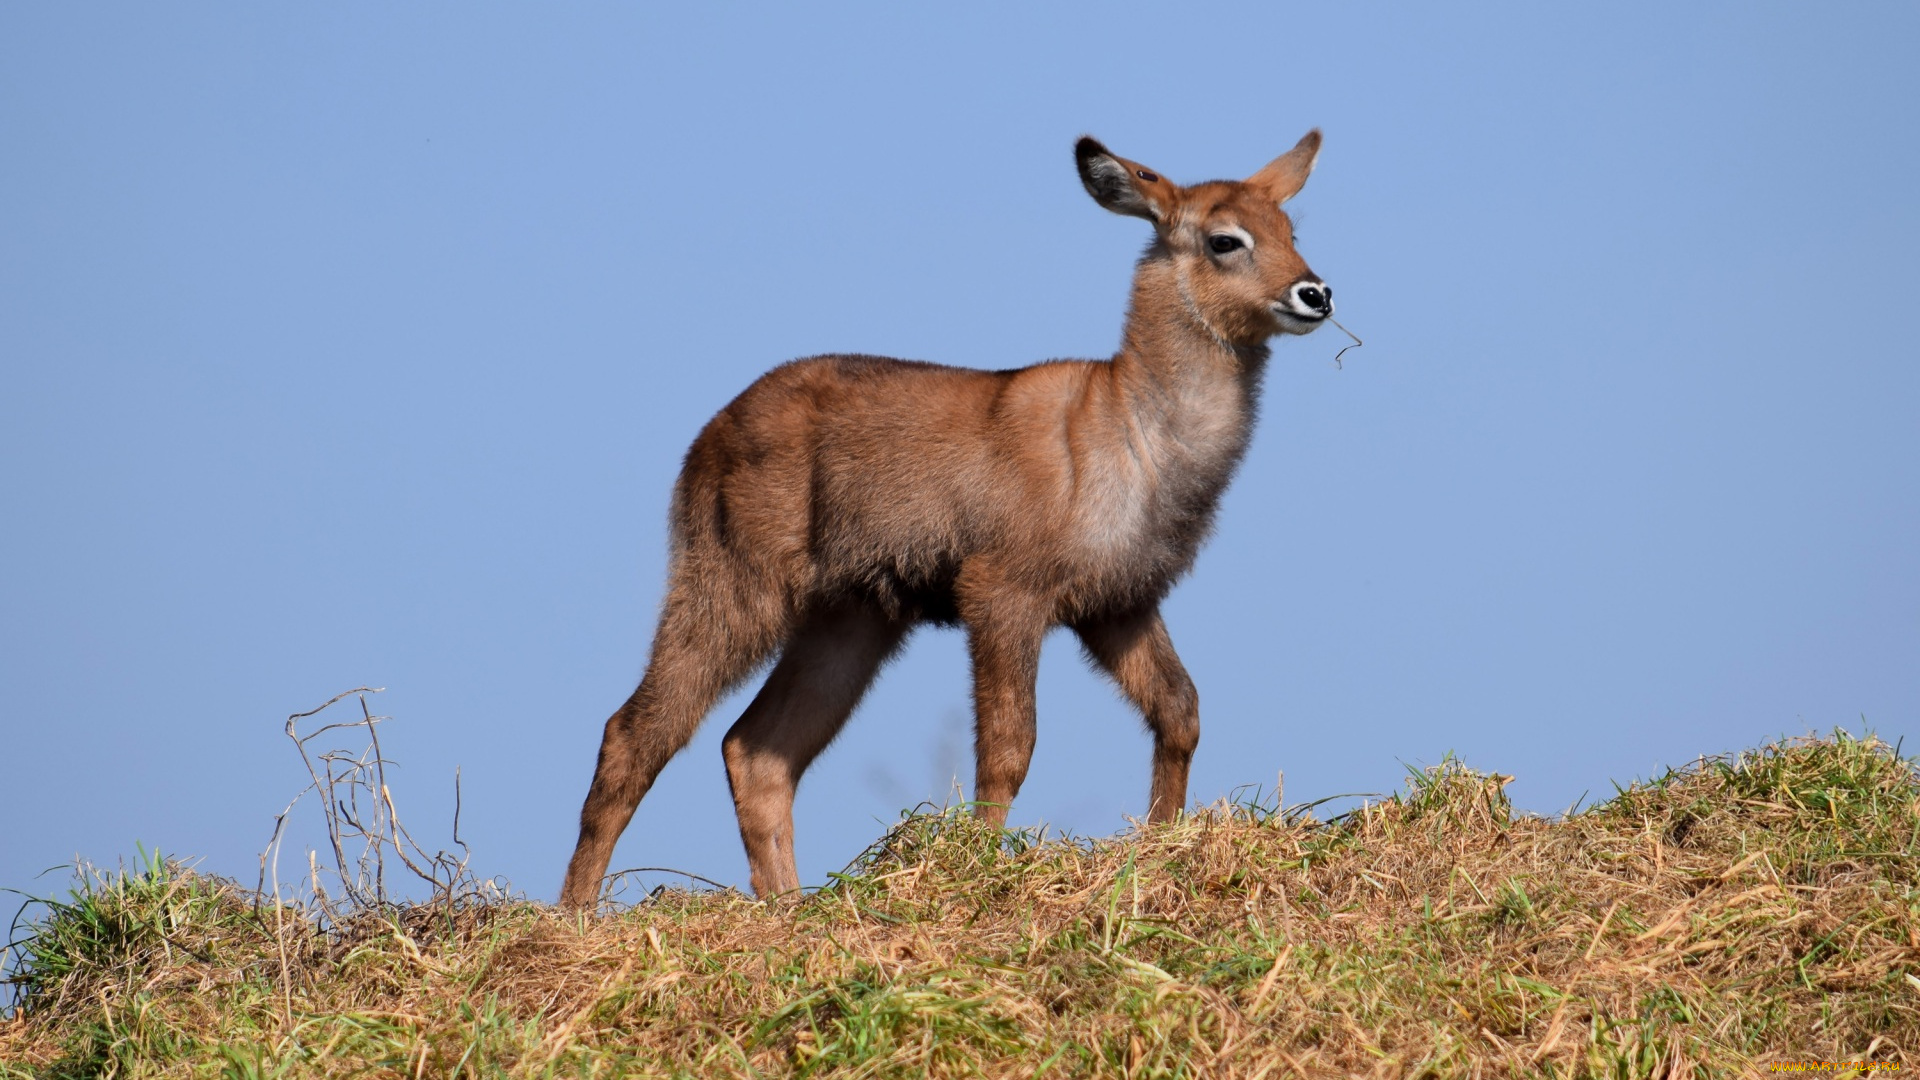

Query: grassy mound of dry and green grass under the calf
left=0, top=734, right=1920, bottom=1078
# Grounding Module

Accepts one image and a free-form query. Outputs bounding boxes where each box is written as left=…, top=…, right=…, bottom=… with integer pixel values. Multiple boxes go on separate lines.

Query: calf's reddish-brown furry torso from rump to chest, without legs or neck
left=674, top=356, right=1206, bottom=623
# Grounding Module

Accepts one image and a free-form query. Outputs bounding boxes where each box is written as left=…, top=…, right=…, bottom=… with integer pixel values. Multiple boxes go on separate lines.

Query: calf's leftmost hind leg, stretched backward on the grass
left=561, top=565, right=785, bottom=907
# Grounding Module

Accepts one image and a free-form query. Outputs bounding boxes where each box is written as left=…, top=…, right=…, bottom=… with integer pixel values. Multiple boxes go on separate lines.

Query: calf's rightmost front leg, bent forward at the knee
left=1073, top=607, right=1200, bottom=822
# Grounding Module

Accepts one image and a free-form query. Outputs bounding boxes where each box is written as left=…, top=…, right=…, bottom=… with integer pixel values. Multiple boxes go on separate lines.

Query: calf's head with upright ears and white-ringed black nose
left=1073, top=129, right=1332, bottom=344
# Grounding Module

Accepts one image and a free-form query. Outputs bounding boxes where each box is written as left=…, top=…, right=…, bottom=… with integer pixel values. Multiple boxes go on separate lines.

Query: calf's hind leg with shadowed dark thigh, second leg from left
left=722, top=605, right=906, bottom=897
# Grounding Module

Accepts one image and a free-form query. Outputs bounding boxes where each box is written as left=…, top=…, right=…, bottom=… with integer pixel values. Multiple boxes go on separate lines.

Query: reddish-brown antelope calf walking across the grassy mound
left=561, top=131, right=1332, bottom=907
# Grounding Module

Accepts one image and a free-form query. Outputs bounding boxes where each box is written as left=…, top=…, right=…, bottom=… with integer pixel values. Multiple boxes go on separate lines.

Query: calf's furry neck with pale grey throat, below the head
left=1114, top=256, right=1267, bottom=480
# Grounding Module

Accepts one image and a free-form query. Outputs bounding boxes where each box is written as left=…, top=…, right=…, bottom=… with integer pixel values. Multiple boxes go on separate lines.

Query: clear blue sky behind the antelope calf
left=0, top=4, right=1920, bottom=897
